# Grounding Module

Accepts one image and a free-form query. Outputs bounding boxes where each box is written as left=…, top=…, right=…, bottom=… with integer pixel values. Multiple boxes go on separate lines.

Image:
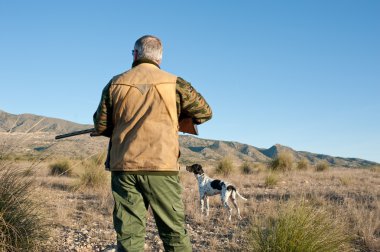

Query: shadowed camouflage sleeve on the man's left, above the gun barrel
left=93, top=80, right=113, bottom=137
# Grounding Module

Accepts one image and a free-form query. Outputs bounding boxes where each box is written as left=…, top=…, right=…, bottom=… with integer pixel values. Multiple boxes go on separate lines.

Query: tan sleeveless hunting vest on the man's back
left=110, top=63, right=179, bottom=172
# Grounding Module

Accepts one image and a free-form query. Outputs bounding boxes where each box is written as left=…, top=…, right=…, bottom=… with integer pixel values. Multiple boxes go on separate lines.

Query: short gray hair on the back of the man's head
left=135, top=35, right=162, bottom=63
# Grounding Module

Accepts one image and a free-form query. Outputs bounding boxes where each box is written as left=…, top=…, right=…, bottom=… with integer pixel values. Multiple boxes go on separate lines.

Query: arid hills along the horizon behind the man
left=0, top=110, right=376, bottom=167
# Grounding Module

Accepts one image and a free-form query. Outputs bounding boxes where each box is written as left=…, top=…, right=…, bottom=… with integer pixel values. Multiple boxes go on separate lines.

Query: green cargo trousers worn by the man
left=112, top=172, right=192, bottom=252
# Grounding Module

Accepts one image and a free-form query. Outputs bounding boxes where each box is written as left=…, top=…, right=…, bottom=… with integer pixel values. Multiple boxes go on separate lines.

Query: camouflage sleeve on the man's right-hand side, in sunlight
left=177, top=77, right=212, bottom=124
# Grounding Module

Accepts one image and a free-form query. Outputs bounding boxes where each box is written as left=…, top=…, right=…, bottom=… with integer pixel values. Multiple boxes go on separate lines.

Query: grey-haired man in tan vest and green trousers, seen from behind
left=94, top=35, right=212, bottom=251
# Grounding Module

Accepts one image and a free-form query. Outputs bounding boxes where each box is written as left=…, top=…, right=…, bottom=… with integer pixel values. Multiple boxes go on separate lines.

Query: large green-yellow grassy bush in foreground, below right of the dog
left=249, top=204, right=349, bottom=252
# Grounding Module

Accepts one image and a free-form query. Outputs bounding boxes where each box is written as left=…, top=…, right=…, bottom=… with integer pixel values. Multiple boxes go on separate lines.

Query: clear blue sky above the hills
left=0, top=0, right=380, bottom=162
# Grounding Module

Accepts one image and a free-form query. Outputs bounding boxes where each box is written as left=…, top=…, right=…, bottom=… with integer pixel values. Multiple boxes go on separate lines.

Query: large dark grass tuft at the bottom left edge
left=0, top=166, right=48, bottom=251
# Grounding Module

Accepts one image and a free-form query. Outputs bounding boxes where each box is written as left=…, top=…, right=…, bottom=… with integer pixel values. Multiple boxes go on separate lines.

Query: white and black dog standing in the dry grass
left=186, top=164, right=247, bottom=220
